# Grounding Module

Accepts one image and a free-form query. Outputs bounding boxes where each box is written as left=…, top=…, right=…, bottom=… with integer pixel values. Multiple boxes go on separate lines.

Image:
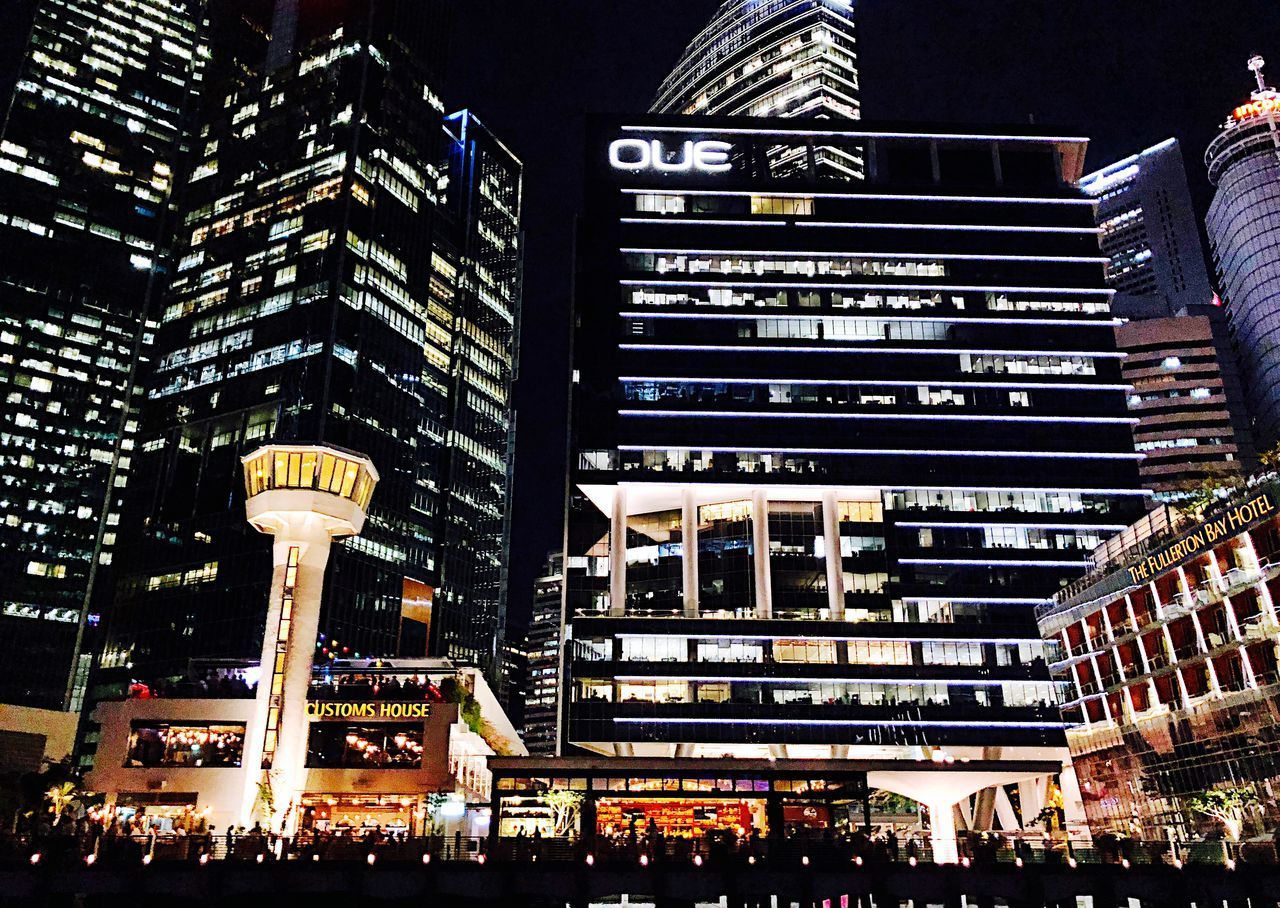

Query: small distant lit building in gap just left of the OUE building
left=525, top=552, right=564, bottom=757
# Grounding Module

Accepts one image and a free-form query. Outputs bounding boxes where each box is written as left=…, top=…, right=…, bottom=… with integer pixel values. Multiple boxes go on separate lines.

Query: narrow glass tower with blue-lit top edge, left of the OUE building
left=434, top=110, right=524, bottom=667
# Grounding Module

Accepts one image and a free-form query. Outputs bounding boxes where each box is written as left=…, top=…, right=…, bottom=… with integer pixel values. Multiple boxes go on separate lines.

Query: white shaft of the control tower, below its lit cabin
left=241, top=525, right=332, bottom=830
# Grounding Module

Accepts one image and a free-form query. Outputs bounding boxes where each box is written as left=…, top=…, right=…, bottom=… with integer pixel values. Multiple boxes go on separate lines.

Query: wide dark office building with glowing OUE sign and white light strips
left=562, top=118, right=1144, bottom=844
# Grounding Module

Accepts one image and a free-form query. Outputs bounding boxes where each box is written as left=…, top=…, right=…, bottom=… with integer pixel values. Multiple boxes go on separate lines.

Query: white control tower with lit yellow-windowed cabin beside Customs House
left=242, top=444, right=378, bottom=830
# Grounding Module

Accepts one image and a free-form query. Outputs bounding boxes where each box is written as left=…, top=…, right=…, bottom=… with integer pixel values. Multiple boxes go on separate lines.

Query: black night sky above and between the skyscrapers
left=449, top=0, right=1280, bottom=624
